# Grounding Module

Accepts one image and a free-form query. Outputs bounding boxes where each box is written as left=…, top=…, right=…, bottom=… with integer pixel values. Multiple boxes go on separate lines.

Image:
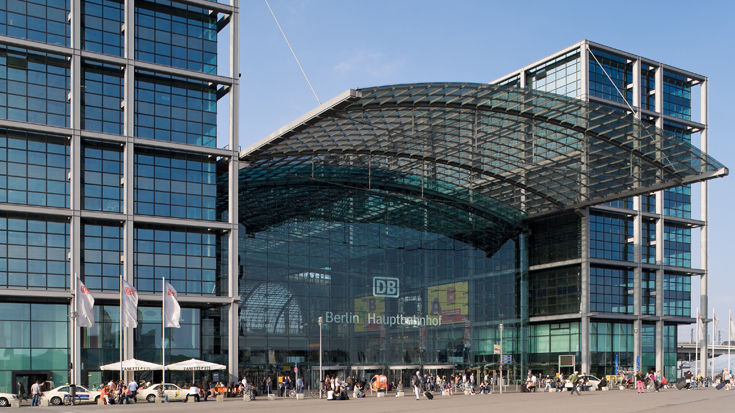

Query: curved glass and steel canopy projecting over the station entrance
left=240, top=83, right=728, bottom=232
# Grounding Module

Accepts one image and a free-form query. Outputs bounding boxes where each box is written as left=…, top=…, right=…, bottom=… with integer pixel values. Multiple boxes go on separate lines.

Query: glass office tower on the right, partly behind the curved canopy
left=492, top=41, right=708, bottom=377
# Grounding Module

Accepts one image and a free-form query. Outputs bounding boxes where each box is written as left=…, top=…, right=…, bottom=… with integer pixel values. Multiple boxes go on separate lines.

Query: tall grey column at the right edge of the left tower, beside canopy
left=227, top=0, right=240, bottom=381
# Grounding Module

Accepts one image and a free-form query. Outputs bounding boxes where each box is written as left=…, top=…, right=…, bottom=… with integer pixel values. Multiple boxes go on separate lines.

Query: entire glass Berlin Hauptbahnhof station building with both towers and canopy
left=0, top=0, right=728, bottom=392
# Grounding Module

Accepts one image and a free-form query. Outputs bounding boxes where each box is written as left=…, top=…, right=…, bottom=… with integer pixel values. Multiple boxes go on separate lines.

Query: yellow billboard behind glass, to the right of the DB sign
left=426, top=281, right=469, bottom=324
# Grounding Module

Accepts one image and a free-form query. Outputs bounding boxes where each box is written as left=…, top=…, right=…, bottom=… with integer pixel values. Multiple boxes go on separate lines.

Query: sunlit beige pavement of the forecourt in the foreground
left=11, top=388, right=735, bottom=413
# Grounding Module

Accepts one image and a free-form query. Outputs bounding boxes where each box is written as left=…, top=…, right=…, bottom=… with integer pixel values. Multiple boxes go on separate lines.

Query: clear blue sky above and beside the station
left=231, top=0, right=735, bottom=340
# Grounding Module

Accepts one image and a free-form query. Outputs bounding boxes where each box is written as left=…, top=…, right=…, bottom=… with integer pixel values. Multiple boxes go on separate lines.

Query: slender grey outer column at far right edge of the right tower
left=699, top=79, right=714, bottom=374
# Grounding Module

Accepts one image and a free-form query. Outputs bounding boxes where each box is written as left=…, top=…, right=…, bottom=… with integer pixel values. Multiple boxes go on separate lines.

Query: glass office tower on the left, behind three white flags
left=0, top=0, right=239, bottom=392
